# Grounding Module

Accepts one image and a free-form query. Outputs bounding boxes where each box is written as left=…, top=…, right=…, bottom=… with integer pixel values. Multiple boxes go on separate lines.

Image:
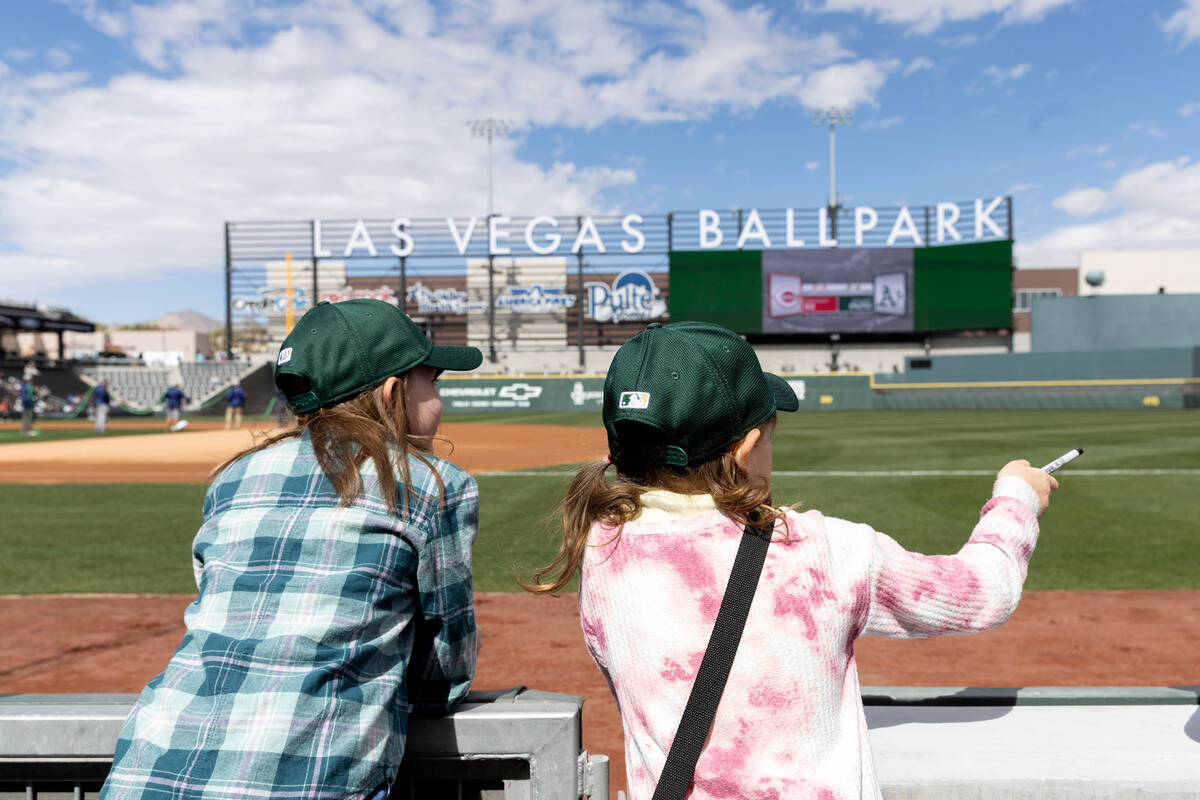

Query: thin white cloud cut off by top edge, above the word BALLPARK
left=821, top=0, right=1080, bottom=34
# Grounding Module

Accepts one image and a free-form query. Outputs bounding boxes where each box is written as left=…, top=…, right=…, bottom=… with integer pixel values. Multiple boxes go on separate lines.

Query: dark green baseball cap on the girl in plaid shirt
left=275, top=299, right=484, bottom=414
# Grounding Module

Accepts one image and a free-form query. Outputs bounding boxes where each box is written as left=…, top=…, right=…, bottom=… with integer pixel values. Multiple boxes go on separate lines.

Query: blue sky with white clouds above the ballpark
left=0, top=0, right=1200, bottom=323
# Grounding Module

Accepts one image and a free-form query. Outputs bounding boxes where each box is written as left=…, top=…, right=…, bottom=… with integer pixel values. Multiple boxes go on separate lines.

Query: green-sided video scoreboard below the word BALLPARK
left=671, top=240, right=1013, bottom=335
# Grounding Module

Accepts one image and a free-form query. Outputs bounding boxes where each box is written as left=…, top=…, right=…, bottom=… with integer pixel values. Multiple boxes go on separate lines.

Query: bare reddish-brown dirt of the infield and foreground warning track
left=0, top=422, right=1200, bottom=790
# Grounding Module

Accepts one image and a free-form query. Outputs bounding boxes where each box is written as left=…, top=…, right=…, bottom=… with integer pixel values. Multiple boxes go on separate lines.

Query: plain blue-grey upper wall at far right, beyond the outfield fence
left=1032, top=292, right=1200, bottom=353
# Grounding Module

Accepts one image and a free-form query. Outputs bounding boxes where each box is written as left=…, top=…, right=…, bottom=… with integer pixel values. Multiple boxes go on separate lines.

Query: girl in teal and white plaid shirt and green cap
left=100, top=300, right=482, bottom=800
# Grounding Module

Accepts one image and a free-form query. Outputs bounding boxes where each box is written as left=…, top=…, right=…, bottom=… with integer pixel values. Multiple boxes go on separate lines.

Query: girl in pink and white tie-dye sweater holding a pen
left=530, top=323, right=1057, bottom=800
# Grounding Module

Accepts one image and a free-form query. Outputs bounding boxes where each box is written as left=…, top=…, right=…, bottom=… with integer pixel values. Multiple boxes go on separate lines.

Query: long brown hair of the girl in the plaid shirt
left=210, top=373, right=445, bottom=513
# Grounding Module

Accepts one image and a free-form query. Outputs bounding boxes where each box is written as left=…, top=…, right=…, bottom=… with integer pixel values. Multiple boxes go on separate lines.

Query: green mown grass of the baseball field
left=0, top=411, right=1200, bottom=593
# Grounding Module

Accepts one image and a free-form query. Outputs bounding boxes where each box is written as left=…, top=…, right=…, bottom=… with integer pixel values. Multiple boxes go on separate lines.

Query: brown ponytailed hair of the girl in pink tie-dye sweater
left=517, top=417, right=784, bottom=594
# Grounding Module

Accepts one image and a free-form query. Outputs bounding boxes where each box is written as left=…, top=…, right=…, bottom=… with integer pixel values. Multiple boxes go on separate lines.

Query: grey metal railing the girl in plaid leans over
left=0, top=687, right=608, bottom=800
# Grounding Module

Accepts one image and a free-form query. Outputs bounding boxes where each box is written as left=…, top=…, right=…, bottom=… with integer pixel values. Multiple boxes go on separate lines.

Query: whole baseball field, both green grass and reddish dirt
left=0, top=410, right=1200, bottom=788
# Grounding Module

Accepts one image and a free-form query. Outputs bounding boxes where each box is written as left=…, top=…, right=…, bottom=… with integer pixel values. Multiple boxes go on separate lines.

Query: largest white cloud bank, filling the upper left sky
left=0, top=0, right=899, bottom=296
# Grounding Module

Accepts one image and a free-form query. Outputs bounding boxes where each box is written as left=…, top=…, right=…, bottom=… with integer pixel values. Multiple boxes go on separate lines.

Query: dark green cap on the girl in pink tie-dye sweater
left=604, top=323, right=800, bottom=467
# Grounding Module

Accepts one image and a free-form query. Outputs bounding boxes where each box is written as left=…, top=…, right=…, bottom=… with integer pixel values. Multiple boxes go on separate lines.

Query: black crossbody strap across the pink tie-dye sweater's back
left=654, top=524, right=772, bottom=800
